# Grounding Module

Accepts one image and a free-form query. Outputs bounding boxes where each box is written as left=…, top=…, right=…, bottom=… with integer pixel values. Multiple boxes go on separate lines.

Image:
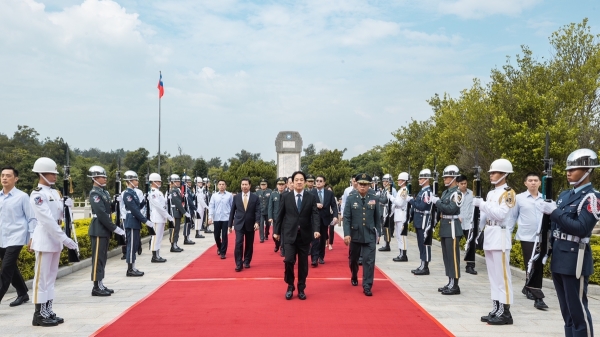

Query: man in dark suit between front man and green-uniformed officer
left=310, top=175, right=338, bottom=267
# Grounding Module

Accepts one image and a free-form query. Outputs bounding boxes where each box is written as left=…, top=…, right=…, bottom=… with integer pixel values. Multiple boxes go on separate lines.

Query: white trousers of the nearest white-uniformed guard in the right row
left=485, top=250, right=513, bottom=304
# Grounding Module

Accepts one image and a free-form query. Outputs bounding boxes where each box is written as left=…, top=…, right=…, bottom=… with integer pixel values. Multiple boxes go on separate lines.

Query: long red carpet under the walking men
left=94, top=233, right=452, bottom=337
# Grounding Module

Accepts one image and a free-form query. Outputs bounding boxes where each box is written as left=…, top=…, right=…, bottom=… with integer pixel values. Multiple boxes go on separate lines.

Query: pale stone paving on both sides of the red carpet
left=0, top=227, right=600, bottom=337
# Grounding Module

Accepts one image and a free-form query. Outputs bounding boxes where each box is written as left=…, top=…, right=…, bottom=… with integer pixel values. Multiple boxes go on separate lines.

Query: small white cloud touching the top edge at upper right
left=438, top=0, right=542, bottom=19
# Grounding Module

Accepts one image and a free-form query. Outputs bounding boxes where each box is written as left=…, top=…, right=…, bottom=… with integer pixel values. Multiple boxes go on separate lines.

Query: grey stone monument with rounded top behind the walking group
left=275, top=131, right=302, bottom=177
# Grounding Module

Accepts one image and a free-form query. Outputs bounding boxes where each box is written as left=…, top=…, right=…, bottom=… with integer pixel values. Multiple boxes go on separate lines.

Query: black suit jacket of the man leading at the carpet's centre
left=273, top=191, right=319, bottom=244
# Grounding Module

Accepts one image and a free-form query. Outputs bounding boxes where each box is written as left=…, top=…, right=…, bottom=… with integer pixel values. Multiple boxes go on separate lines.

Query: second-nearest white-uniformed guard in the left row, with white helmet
left=148, top=173, right=175, bottom=263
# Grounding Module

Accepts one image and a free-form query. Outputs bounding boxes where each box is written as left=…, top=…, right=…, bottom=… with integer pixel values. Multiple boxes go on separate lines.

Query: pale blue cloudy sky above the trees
left=0, top=0, right=600, bottom=160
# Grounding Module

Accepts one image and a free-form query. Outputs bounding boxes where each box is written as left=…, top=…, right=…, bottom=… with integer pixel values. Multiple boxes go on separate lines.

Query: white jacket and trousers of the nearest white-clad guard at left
left=29, top=184, right=70, bottom=304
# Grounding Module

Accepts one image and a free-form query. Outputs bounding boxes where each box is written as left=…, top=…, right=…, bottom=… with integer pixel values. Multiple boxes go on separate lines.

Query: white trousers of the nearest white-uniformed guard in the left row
left=33, top=251, right=60, bottom=304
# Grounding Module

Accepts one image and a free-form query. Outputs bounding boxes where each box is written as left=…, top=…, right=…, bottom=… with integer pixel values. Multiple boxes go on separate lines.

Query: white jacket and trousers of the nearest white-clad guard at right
left=479, top=184, right=516, bottom=304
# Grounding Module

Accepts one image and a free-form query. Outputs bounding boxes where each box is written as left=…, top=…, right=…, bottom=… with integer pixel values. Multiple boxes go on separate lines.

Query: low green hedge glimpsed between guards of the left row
left=17, top=218, right=148, bottom=280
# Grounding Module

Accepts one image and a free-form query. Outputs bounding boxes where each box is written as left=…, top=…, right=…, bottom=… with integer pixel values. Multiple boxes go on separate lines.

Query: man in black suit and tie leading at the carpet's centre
left=273, top=171, right=320, bottom=300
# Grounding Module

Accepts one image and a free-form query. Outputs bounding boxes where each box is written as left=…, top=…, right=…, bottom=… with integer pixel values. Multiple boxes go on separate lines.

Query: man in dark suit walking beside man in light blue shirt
left=229, top=178, right=260, bottom=271
